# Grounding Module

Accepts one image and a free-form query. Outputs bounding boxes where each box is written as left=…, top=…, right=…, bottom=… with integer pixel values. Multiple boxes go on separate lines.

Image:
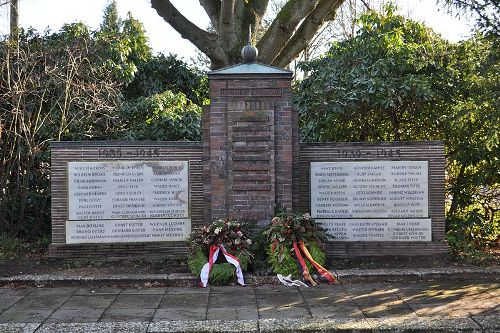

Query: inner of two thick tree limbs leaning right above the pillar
left=257, top=0, right=322, bottom=64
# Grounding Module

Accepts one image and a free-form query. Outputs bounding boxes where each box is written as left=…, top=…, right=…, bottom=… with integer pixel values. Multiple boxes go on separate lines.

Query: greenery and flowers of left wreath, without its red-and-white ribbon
left=188, top=220, right=252, bottom=285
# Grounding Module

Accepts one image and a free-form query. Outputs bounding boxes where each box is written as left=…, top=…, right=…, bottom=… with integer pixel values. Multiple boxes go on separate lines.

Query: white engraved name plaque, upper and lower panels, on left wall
left=66, top=161, right=191, bottom=243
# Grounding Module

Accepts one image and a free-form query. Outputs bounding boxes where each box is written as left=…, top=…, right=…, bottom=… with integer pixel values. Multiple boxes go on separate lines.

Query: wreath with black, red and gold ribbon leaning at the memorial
left=264, top=213, right=336, bottom=286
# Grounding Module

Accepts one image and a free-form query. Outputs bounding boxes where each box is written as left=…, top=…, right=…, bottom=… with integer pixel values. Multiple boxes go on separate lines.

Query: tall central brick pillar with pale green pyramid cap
left=203, top=63, right=298, bottom=224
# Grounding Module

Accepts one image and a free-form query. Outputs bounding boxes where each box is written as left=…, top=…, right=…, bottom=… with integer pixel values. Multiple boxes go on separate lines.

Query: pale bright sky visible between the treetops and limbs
left=0, top=0, right=472, bottom=60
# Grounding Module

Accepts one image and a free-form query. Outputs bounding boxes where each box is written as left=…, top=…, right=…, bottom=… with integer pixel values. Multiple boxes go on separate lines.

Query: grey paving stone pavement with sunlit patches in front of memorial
left=0, top=280, right=500, bottom=333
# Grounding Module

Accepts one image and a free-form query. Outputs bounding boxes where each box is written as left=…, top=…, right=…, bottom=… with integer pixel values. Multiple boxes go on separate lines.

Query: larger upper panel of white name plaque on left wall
left=68, top=161, right=189, bottom=221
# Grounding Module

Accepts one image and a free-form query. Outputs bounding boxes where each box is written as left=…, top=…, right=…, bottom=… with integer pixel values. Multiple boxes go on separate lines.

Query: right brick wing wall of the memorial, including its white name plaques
left=299, top=141, right=447, bottom=257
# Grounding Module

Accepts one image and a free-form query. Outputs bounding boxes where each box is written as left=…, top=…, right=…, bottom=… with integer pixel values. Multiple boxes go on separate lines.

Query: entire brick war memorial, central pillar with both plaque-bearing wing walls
left=50, top=44, right=447, bottom=259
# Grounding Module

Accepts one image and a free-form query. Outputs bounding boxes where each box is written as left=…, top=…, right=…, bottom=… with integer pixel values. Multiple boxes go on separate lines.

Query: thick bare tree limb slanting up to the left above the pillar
left=151, top=0, right=227, bottom=63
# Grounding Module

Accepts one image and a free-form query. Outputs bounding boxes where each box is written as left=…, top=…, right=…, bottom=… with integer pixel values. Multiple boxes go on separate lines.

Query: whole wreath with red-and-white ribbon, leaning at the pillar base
left=188, top=219, right=252, bottom=287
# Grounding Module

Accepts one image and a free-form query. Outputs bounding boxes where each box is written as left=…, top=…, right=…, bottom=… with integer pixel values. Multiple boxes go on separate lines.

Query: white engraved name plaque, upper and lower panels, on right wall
left=310, top=161, right=432, bottom=241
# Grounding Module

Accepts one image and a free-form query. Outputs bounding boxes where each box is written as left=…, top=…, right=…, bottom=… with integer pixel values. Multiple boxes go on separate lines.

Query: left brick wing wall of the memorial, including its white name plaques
left=49, top=142, right=203, bottom=258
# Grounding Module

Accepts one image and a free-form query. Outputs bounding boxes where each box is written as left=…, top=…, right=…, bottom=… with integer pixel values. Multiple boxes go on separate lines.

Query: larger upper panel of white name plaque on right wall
left=311, top=161, right=429, bottom=218
